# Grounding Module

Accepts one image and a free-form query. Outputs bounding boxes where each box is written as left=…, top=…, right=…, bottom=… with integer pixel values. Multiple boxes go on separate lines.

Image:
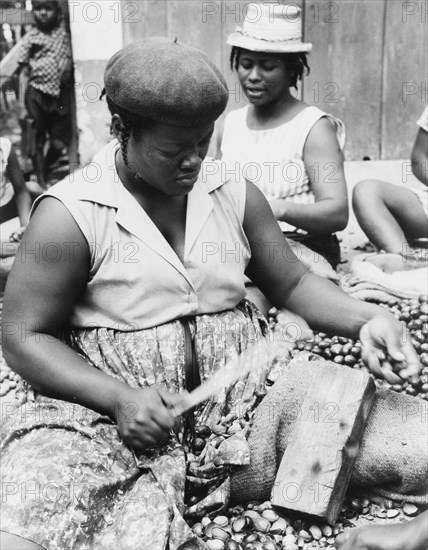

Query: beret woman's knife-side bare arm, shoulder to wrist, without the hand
left=3, top=198, right=129, bottom=416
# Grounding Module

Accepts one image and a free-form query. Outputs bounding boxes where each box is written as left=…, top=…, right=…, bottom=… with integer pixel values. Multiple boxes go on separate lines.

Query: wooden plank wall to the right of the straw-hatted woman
left=305, top=0, right=428, bottom=159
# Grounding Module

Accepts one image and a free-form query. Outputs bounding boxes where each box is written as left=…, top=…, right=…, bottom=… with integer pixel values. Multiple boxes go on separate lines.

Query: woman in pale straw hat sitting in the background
left=221, top=4, right=348, bottom=294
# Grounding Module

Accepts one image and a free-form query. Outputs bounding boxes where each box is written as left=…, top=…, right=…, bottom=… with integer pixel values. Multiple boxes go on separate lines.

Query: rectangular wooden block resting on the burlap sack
left=271, top=362, right=376, bottom=524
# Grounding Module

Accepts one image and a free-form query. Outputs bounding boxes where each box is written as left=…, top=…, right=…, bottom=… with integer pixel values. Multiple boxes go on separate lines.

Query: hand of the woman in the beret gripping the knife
left=115, top=388, right=181, bottom=451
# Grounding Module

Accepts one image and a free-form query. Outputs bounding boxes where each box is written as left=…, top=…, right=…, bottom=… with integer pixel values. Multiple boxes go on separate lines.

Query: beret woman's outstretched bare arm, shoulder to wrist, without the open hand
left=244, top=183, right=376, bottom=338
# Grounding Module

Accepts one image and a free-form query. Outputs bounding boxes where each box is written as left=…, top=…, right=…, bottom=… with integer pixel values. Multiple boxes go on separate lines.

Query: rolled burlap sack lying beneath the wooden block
left=231, top=361, right=428, bottom=504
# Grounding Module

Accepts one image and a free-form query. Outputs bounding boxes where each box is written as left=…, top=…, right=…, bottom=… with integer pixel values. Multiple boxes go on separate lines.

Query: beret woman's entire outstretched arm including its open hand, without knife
left=244, top=183, right=420, bottom=383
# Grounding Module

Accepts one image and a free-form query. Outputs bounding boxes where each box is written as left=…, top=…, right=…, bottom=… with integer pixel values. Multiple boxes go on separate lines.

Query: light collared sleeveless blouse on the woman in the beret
left=33, top=141, right=250, bottom=331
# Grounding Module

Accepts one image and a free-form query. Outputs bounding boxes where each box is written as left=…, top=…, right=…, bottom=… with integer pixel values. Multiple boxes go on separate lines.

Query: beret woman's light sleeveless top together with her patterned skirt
left=1, top=144, right=290, bottom=550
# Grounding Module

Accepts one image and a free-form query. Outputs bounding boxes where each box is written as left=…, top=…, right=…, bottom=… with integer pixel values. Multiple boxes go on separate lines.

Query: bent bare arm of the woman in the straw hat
left=271, top=118, right=348, bottom=234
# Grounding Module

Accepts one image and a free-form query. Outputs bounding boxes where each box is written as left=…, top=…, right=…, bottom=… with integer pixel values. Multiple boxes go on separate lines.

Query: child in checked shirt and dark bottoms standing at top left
left=18, top=0, right=72, bottom=188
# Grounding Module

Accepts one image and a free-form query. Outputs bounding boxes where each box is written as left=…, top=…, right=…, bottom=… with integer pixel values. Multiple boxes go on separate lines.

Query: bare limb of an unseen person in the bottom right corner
left=336, top=511, right=428, bottom=550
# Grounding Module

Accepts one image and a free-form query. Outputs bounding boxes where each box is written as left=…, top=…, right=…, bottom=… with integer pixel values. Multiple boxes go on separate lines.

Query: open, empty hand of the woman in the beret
left=360, top=314, right=421, bottom=384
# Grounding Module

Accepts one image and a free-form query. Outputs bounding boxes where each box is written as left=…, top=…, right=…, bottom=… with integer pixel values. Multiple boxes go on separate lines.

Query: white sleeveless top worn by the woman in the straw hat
left=221, top=106, right=345, bottom=231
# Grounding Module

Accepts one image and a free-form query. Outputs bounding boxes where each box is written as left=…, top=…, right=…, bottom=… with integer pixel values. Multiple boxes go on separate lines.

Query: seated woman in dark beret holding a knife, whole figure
left=0, top=38, right=420, bottom=550
